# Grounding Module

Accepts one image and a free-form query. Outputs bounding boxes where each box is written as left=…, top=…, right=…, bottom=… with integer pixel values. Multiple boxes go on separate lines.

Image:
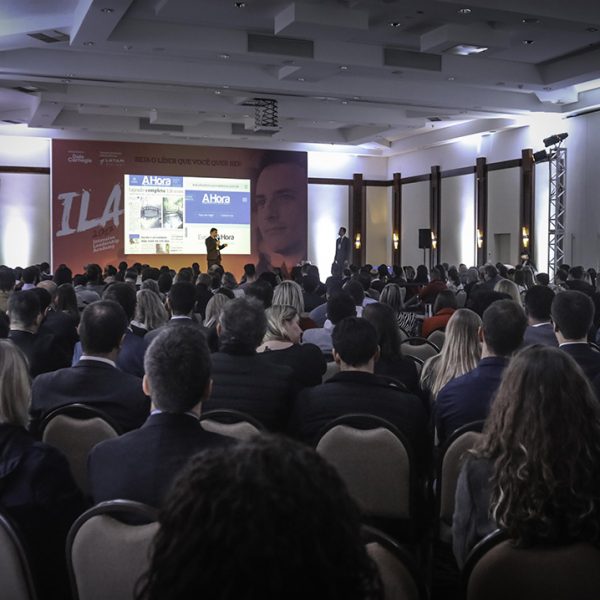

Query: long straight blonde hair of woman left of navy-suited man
left=420, top=308, right=481, bottom=403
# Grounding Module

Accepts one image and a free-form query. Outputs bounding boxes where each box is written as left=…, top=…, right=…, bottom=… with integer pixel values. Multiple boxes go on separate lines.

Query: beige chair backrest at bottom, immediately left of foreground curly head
left=67, top=500, right=158, bottom=600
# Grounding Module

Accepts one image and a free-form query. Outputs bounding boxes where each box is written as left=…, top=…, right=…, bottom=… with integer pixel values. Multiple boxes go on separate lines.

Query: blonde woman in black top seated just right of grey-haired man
left=256, top=308, right=327, bottom=387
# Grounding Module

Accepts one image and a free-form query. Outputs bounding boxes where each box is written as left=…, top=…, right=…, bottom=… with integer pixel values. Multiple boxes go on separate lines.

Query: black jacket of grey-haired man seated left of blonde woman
left=202, top=352, right=295, bottom=431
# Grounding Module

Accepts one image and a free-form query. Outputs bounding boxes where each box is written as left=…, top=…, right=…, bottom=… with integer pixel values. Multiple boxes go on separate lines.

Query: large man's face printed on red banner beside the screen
left=256, top=163, right=306, bottom=254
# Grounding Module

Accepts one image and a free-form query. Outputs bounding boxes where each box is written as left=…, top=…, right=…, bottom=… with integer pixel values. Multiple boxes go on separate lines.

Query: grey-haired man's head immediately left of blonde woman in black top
left=217, top=298, right=267, bottom=354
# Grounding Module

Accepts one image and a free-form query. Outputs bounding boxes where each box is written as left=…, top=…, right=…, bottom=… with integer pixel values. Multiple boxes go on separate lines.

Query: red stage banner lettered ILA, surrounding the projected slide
left=52, top=140, right=307, bottom=273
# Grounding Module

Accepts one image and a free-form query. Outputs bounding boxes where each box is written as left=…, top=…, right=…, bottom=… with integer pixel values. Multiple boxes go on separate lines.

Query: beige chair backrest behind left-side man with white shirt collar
left=41, top=404, right=120, bottom=494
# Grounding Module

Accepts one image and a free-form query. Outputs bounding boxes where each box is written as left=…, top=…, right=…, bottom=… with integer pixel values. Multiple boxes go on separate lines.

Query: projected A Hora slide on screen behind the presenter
left=123, top=175, right=250, bottom=254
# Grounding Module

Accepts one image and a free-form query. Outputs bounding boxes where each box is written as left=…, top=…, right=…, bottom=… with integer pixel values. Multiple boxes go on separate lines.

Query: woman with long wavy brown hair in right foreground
left=452, top=346, right=600, bottom=565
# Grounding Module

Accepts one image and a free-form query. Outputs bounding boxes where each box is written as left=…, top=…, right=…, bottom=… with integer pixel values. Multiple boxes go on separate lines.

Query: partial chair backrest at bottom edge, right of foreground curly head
left=361, top=525, right=427, bottom=600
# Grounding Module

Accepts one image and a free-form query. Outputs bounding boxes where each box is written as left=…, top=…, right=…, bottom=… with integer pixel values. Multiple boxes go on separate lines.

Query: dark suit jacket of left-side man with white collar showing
left=29, top=360, right=150, bottom=435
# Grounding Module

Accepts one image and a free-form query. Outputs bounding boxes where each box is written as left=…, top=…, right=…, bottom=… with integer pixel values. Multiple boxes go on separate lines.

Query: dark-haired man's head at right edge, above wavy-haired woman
left=550, top=290, right=594, bottom=343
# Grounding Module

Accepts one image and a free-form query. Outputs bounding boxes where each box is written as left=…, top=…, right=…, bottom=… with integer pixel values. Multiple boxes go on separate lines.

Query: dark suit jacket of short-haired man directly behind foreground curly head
left=88, top=413, right=233, bottom=507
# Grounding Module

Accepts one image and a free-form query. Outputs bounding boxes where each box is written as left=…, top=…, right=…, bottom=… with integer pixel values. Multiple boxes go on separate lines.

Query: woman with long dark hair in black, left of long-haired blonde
left=363, top=302, right=419, bottom=394
